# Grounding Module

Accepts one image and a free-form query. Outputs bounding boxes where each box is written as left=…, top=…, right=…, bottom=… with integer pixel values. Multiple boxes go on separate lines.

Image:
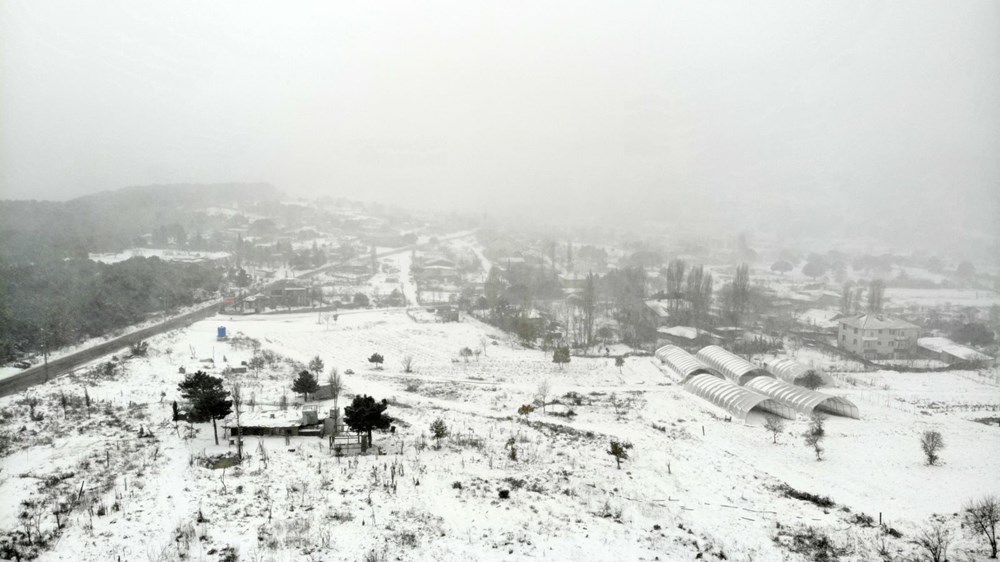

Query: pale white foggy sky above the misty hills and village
left=0, top=0, right=1000, bottom=233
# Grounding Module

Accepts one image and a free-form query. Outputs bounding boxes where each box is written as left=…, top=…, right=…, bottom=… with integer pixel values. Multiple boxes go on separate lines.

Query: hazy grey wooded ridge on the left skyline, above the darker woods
left=0, top=183, right=280, bottom=262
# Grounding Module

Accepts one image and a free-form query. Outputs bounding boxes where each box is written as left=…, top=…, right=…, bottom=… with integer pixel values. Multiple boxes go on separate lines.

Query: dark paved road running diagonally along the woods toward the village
left=0, top=231, right=473, bottom=396
